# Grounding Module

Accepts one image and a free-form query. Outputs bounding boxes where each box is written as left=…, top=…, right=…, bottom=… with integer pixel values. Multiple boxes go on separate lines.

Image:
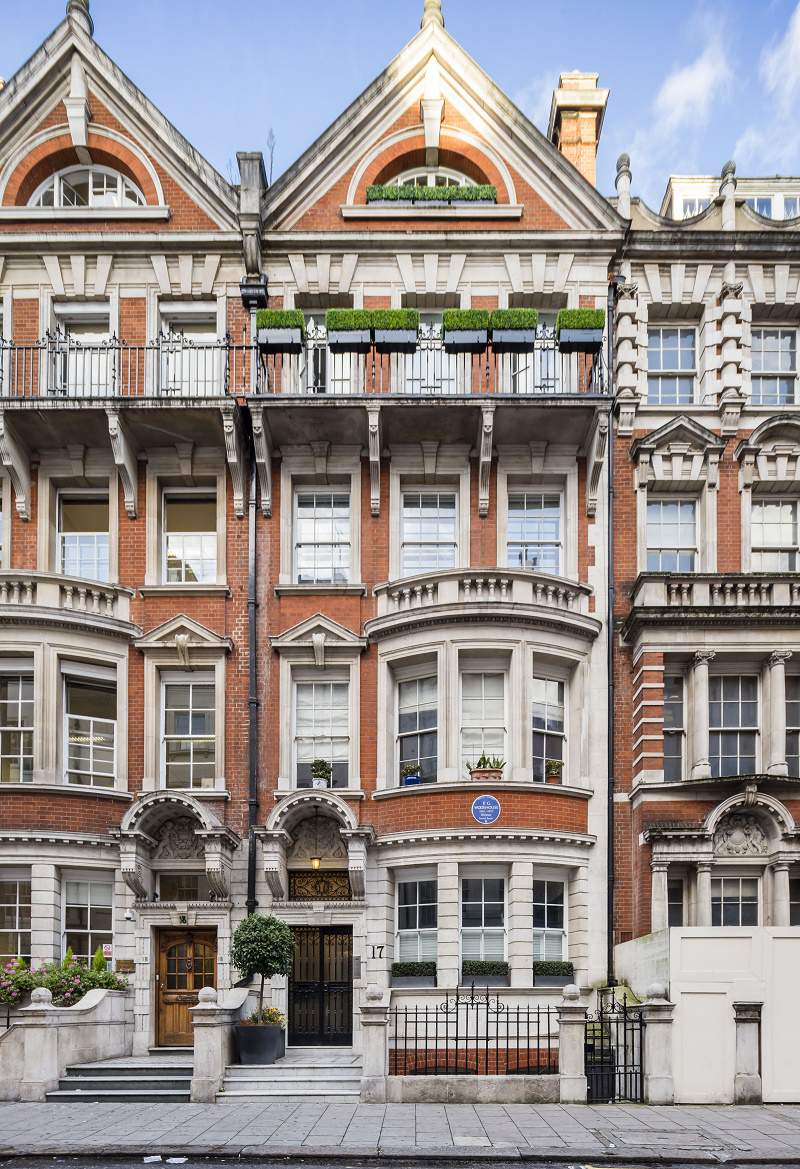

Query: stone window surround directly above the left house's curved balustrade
left=36, top=449, right=119, bottom=585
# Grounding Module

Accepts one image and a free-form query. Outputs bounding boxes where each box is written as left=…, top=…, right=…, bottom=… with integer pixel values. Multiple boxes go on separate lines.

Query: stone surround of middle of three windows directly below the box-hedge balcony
left=389, top=442, right=470, bottom=580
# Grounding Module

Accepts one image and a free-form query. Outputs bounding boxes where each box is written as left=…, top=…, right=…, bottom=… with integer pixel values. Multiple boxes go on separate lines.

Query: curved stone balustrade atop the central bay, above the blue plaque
left=365, top=568, right=600, bottom=638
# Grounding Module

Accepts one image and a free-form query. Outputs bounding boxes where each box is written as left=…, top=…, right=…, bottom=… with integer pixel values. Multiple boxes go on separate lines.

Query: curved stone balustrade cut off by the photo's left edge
left=0, top=569, right=142, bottom=637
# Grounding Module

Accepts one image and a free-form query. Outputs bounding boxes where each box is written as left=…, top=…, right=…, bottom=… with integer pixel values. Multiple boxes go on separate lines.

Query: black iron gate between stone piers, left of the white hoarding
left=584, top=990, right=644, bottom=1104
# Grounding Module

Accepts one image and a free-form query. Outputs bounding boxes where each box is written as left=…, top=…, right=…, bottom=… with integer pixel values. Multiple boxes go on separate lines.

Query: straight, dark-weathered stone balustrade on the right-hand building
left=625, top=573, right=800, bottom=636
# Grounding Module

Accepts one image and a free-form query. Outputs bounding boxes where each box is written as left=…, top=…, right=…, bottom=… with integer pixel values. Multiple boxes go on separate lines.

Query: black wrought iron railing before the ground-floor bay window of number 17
left=389, top=985, right=558, bottom=1075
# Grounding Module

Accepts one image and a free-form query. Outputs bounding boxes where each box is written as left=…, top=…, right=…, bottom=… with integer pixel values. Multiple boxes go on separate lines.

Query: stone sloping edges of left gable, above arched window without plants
left=0, top=12, right=239, bottom=230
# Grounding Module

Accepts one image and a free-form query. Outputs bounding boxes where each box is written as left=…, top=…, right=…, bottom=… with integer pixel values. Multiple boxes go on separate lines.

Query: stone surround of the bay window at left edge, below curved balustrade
left=0, top=629, right=127, bottom=796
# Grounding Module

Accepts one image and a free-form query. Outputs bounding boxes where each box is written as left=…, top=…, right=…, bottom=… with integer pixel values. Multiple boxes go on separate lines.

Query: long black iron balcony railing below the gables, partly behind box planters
left=0, top=333, right=606, bottom=400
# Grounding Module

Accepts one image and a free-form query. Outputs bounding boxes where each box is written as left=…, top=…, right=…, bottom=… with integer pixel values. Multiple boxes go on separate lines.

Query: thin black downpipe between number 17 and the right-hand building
left=606, top=279, right=616, bottom=987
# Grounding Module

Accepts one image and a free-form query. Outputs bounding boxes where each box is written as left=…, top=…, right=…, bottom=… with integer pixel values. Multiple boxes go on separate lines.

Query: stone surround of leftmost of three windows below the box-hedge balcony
left=278, top=442, right=363, bottom=593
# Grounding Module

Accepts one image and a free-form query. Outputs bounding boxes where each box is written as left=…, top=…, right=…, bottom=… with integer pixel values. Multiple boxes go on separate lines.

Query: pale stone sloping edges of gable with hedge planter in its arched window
left=264, top=22, right=625, bottom=231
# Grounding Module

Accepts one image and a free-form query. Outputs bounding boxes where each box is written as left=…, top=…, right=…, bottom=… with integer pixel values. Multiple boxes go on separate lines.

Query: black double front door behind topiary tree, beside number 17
left=289, top=926, right=353, bottom=1047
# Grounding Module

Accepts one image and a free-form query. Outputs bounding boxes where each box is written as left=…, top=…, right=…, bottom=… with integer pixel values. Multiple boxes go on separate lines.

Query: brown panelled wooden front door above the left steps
left=156, top=929, right=216, bottom=1047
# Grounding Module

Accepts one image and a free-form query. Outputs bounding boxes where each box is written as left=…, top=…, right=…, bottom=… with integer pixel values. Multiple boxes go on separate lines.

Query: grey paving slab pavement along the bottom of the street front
left=0, top=1100, right=800, bottom=1165
